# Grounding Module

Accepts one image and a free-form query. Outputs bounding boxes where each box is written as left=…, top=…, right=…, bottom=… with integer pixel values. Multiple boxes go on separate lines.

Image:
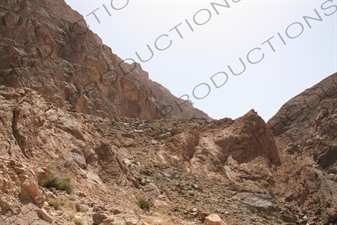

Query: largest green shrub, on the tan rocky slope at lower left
left=40, top=173, right=73, bottom=194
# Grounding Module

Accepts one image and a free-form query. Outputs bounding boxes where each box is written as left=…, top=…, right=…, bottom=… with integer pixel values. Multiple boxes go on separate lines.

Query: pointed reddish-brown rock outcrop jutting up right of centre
left=158, top=110, right=280, bottom=189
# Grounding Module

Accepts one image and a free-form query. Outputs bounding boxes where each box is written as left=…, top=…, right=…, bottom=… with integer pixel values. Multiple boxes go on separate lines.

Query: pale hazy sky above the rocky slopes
left=66, top=0, right=337, bottom=120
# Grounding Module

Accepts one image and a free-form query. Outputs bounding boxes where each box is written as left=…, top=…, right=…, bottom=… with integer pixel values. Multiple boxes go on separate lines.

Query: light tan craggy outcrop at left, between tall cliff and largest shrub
left=0, top=86, right=137, bottom=222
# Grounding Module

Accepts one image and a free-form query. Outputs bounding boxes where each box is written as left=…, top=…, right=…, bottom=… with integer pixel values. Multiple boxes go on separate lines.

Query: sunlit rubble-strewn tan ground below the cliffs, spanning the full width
left=0, top=75, right=337, bottom=225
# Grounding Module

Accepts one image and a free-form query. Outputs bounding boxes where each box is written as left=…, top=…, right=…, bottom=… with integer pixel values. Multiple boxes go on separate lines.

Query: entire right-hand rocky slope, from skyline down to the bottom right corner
left=268, top=73, right=337, bottom=224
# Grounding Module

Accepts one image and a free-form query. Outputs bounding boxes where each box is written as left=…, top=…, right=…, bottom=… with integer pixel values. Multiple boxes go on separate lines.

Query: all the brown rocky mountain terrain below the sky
left=0, top=0, right=337, bottom=225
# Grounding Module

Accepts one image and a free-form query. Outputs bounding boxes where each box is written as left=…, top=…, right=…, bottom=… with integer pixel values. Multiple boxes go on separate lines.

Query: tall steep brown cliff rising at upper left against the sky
left=0, top=0, right=208, bottom=118
